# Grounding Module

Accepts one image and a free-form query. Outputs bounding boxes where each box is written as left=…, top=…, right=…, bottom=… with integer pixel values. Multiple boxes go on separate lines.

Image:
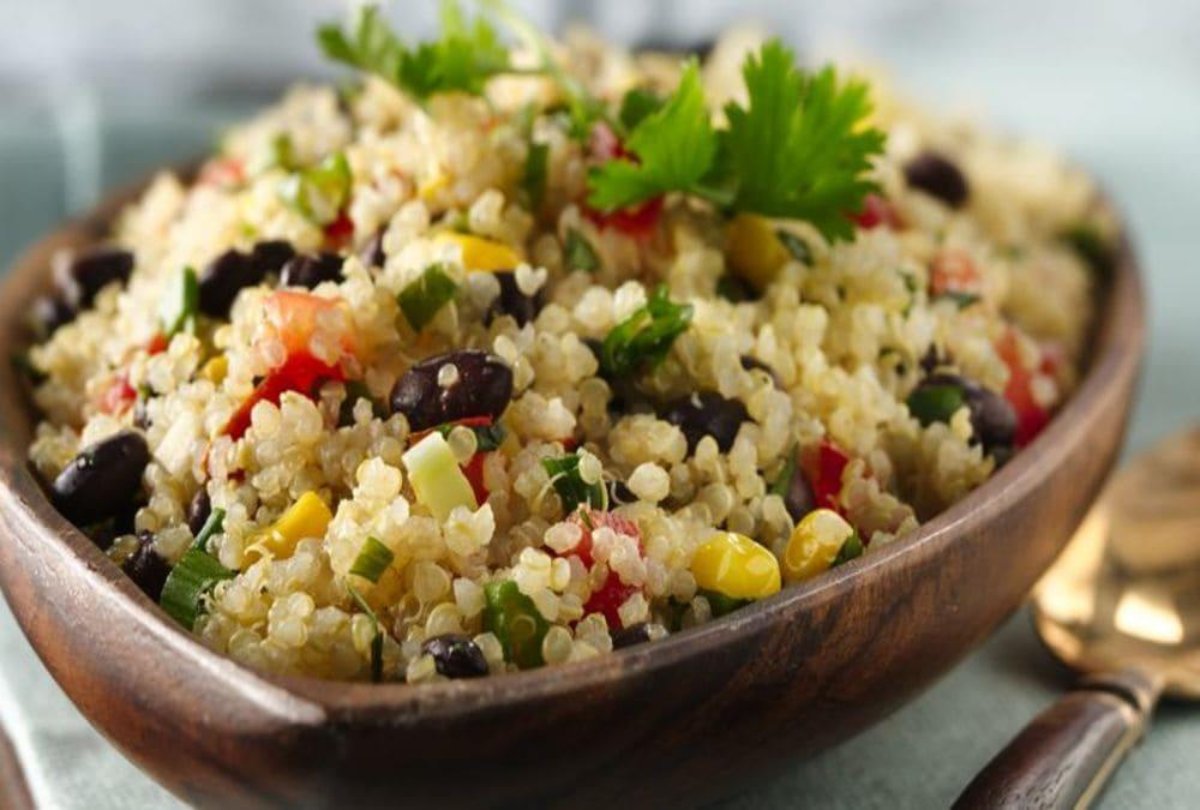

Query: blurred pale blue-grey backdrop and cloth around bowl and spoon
left=0, top=0, right=1200, bottom=809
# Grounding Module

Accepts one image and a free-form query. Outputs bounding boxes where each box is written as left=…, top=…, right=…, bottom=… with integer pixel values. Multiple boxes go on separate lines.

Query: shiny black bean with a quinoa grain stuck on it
left=391, top=349, right=512, bottom=431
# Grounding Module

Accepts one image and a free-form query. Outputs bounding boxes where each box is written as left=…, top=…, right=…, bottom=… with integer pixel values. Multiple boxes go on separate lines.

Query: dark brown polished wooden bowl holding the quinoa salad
left=0, top=178, right=1144, bottom=808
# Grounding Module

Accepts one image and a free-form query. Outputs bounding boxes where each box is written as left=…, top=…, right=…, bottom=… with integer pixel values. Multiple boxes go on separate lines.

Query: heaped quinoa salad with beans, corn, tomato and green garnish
left=20, top=4, right=1116, bottom=683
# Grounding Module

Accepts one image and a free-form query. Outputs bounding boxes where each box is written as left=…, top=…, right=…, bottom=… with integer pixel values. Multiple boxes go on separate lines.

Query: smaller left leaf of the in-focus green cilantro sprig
left=588, top=61, right=718, bottom=211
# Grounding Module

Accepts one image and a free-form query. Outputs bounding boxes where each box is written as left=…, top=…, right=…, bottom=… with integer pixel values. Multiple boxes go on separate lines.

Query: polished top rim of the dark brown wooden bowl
left=0, top=169, right=1145, bottom=725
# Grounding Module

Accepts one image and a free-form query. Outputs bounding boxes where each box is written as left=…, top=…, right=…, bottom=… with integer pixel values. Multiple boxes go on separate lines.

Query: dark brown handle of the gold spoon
left=954, top=670, right=1163, bottom=810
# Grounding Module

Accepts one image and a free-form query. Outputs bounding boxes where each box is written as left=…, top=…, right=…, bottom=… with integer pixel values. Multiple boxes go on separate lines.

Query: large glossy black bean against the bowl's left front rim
left=53, top=431, right=150, bottom=526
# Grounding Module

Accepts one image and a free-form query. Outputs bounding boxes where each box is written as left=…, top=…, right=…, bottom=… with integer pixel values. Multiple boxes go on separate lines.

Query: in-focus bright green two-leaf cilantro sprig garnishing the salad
left=588, top=40, right=884, bottom=240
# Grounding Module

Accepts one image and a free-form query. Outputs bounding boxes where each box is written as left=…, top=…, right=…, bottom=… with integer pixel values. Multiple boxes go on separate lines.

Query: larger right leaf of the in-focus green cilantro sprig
left=720, top=40, right=884, bottom=240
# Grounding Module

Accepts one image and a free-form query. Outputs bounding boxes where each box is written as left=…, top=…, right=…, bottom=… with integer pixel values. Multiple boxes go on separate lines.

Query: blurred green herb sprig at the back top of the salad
left=317, top=0, right=510, bottom=101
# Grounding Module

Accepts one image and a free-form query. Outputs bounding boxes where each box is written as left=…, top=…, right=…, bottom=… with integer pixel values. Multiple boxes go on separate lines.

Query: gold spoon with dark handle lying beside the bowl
left=955, top=427, right=1200, bottom=808
